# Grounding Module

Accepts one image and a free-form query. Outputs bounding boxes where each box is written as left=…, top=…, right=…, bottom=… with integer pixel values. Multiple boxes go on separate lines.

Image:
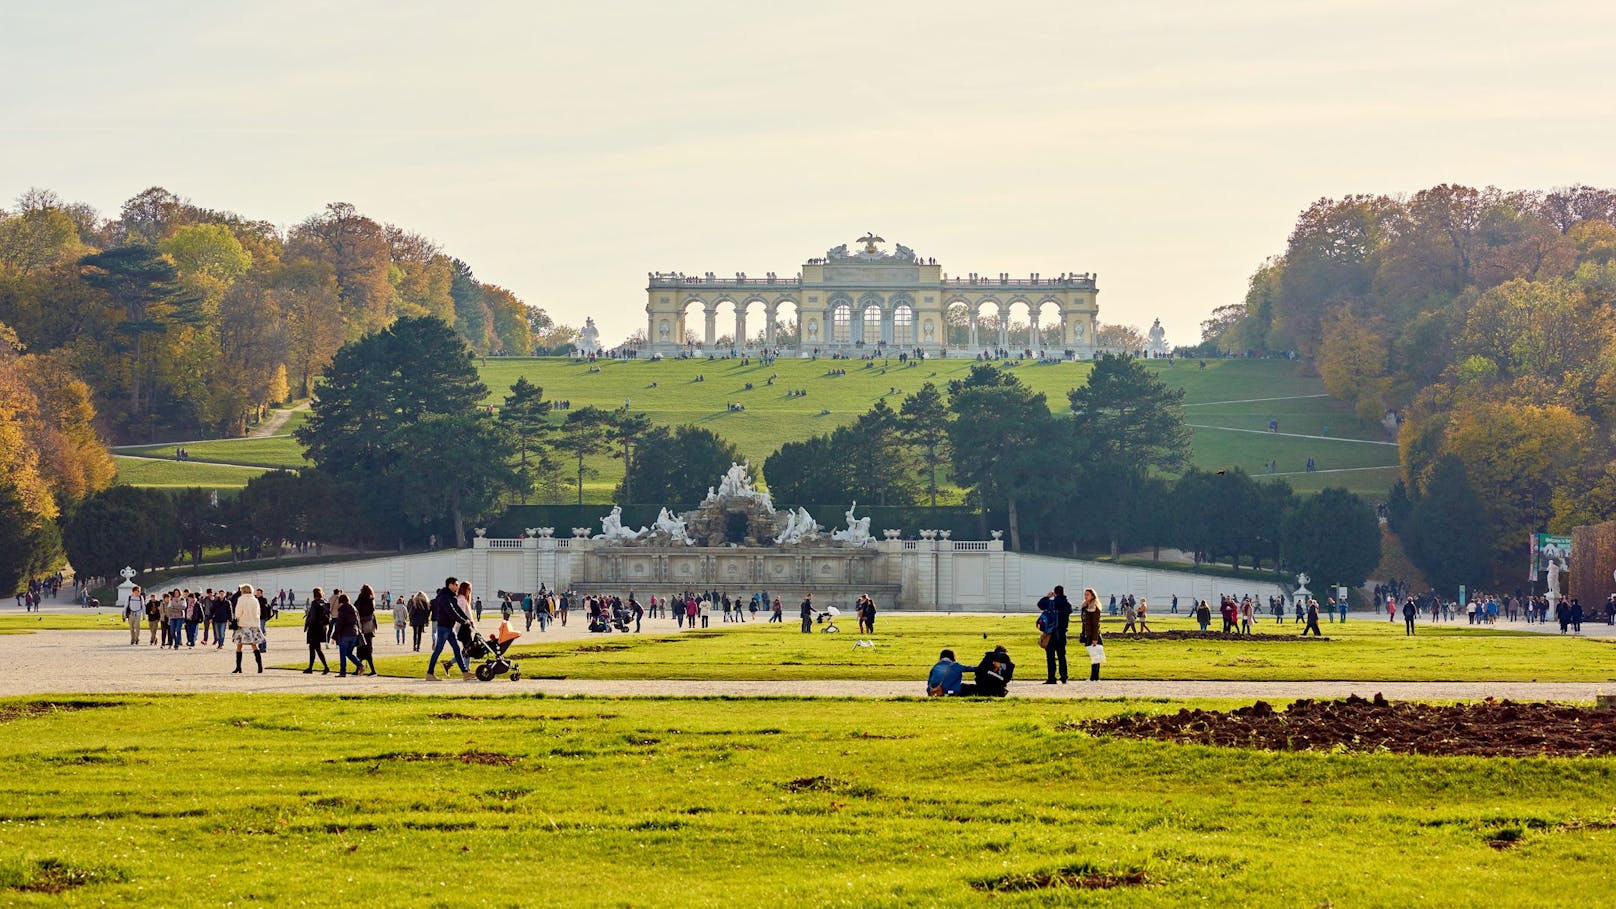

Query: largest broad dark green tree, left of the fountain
left=294, top=317, right=512, bottom=543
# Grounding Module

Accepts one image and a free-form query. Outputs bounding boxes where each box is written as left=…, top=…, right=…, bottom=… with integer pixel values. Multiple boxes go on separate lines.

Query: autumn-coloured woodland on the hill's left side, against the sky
left=0, top=188, right=574, bottom=442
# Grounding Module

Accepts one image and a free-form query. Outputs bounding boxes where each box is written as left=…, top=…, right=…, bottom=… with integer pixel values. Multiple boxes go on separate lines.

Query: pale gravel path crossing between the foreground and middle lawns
left=0, top=619, right=1616, bottom=700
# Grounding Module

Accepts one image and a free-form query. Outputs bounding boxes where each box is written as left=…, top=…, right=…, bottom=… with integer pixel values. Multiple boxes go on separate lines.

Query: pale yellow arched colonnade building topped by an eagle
left=645, top=233, right=1099, bottom=357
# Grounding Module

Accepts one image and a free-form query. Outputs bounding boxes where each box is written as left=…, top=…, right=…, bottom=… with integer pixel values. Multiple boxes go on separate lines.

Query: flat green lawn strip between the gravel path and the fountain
left=366, top=607, right=1616, bottom=691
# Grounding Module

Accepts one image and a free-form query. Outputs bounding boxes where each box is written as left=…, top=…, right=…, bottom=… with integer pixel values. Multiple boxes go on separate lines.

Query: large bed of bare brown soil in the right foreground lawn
left=1068, top=694, right=1616, bottom=757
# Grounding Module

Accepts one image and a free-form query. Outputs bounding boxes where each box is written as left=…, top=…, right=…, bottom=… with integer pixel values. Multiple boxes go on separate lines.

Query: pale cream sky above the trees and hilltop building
left=0, top=0, right=1616, bottom=343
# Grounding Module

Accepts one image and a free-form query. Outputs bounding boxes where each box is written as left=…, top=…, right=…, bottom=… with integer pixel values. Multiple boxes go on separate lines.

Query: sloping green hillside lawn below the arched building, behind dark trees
left=118, top=357, right=1396, bottom=501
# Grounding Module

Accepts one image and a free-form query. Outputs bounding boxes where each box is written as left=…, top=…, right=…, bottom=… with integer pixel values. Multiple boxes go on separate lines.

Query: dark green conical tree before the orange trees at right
left=1404, top=455, right=1492, bottom=597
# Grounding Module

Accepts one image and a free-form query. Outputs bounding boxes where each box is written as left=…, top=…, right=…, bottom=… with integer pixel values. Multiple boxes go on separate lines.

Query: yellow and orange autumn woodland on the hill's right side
left=1202, top=184, right=1616, bottom=587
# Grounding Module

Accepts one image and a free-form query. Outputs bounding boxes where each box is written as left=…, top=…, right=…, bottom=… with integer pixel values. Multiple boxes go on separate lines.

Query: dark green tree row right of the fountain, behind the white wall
left=763, top=356, right=1380, bottom=586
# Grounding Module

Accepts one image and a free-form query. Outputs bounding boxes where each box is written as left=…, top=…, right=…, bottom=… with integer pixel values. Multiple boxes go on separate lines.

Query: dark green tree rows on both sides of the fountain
left=65, top=317, right=1380, bottom=584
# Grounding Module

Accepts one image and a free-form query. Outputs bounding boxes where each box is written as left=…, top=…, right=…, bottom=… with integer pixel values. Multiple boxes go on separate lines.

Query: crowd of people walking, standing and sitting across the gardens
left=18, top=574, right=1616, bottom=695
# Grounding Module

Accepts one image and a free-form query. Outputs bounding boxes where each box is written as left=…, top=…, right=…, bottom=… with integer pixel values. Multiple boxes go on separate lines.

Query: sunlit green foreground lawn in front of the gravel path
left=0, top=694, right=1616, bottom=909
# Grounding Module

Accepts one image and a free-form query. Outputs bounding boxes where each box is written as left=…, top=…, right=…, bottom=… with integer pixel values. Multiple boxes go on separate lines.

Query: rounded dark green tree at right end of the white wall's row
left=1283, top=487, right=1380, bottom=587
